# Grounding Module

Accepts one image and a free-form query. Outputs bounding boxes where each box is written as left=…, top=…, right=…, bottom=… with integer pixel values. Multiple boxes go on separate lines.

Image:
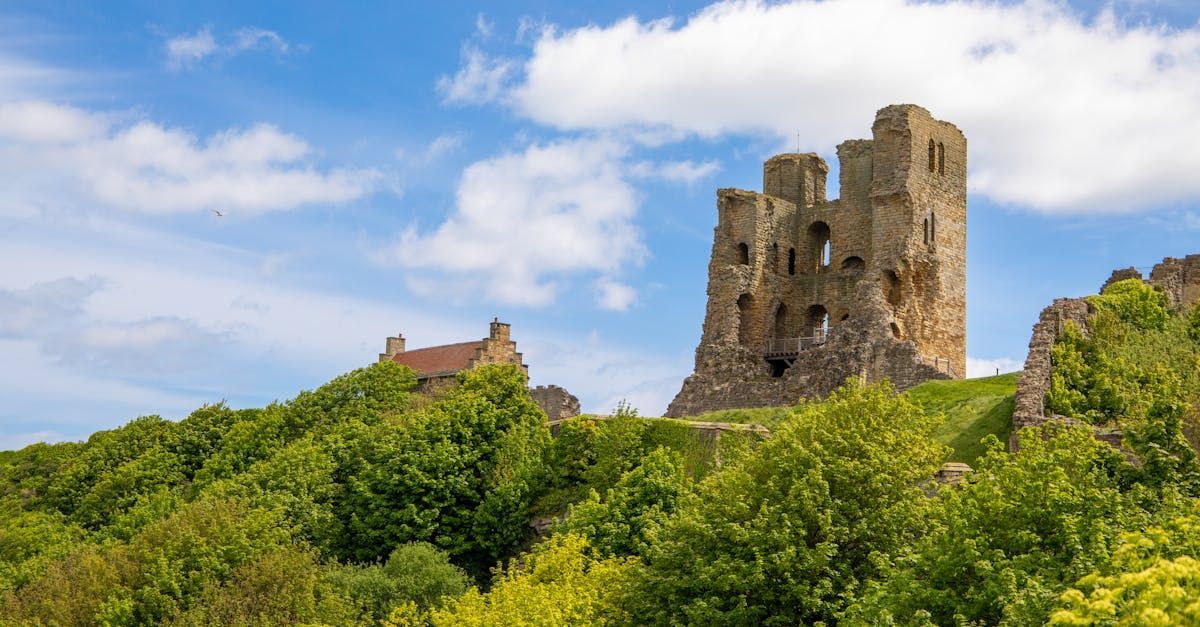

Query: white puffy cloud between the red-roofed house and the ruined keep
left=379, top=138, right=644, bottom=309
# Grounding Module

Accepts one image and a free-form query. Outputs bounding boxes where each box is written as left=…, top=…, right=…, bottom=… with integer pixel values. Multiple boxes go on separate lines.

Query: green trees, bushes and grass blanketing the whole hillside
left=0, top=283, right=1200, bottom=626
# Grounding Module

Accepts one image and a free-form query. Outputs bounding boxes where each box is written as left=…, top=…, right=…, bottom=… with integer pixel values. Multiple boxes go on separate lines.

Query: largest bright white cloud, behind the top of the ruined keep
left=448, top=0, right=1200, bottom=211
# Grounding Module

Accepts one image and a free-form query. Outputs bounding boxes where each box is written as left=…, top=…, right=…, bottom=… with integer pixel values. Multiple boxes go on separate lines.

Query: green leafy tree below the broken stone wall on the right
left=846, top=424, right=1147, bottom=625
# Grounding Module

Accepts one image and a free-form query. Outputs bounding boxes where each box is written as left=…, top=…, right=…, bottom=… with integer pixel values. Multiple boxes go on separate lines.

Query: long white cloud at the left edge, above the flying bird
left=0, top=101, right=382, bottom=215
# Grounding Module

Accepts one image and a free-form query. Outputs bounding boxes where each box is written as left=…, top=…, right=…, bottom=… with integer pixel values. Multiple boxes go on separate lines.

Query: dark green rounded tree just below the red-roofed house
left=337, top=365, right=550, bottom=572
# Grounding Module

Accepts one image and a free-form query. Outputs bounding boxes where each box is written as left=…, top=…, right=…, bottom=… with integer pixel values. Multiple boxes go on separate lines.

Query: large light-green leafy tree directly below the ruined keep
left=630, top=383, right=948, bottom=625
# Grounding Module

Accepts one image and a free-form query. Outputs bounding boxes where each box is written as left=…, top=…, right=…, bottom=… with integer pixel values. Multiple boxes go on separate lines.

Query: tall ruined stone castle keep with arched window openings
left=667, top=105, right=967, bottom=416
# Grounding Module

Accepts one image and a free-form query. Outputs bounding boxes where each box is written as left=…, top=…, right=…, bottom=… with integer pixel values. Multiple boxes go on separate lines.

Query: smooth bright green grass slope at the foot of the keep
left=685, top=372, right=1018, bottom=464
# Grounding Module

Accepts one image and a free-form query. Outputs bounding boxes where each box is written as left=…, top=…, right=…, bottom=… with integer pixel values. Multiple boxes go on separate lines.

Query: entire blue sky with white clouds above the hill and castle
left=0, top=0, right=1200, bottom=448
